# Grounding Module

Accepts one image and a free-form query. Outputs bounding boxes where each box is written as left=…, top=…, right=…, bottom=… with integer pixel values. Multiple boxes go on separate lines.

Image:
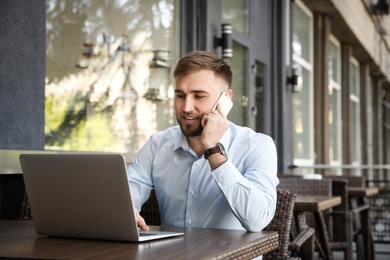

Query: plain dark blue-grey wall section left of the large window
left=0, top=0, right=46, bottom=150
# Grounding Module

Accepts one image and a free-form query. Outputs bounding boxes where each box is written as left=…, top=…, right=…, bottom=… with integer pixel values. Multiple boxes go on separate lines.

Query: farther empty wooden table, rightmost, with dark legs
left=348, top=187, right=379, bottom=260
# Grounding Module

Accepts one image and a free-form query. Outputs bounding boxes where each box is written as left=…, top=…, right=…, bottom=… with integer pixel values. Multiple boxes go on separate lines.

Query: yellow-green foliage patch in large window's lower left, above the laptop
left=45, top=93, right=116, bottom=151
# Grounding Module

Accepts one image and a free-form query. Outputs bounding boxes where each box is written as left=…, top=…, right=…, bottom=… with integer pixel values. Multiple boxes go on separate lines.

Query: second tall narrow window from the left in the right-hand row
left=328, top=37, right=341, bottom=168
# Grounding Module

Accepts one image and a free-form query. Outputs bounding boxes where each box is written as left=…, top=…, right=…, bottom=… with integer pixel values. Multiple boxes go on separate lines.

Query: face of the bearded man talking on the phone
left=175, top=70, right=228, bottom=137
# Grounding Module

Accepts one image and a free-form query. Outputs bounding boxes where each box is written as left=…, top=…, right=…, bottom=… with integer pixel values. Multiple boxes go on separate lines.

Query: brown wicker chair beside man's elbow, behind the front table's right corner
left=263, top=190, right=296, bottom=259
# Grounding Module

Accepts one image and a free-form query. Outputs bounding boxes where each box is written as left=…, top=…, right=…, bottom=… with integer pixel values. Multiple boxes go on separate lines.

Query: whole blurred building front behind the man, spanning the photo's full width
left=0, top=0, right=390, bottom=180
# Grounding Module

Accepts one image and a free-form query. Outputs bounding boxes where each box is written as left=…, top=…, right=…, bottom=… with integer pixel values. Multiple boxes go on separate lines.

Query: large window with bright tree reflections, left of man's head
left=45, top=0, right=180, bottom=152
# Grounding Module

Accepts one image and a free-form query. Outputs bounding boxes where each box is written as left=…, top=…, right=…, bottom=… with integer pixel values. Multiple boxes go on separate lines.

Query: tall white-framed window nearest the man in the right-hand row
left=293, top=2, right=314, bottom=165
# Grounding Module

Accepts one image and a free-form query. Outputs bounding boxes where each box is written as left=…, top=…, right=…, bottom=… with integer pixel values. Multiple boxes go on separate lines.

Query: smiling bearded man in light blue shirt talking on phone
left=128, top=51, right=279, bottom=232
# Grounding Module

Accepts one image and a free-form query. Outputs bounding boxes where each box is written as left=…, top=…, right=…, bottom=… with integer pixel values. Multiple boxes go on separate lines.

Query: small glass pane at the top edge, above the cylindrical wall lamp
left=221, top=0, right=250, bottom=35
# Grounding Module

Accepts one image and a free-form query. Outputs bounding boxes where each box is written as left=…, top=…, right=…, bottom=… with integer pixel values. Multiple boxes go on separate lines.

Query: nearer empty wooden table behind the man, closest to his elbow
left=294, top=195, right=341, bottom=259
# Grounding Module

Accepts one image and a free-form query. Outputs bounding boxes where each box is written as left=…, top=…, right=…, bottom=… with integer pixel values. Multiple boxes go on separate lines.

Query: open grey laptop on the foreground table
left=19, top=153, right=183, bottom=242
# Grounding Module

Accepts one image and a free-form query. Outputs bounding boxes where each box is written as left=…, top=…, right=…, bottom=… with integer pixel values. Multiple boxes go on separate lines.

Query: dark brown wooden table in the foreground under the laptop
left=0, top=220, right=278, bottom=259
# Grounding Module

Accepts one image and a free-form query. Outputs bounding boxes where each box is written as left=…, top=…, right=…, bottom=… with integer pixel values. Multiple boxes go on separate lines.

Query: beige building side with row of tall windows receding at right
left=292, top=0, right=390, bottom=184
